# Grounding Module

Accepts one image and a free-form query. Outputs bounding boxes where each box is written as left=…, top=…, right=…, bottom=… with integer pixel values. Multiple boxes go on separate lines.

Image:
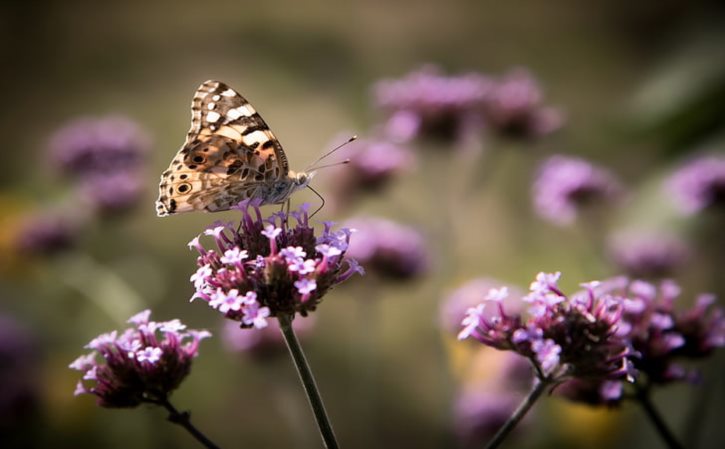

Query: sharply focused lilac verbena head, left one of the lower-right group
left=459, top=273, right=634, bottom=381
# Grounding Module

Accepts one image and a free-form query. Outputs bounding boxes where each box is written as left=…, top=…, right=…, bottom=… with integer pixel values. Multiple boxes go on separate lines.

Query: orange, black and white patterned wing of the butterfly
left=156, top=80, right=289, bottom=217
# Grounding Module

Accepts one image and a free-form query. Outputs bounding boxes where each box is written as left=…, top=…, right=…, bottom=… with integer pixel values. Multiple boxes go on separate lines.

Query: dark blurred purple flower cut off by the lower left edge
left=0, top=314, right=40, bottom=434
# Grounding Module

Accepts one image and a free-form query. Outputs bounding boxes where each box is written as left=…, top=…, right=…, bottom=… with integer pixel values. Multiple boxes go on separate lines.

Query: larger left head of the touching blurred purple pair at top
left=374, top=65, right=493, bottom=141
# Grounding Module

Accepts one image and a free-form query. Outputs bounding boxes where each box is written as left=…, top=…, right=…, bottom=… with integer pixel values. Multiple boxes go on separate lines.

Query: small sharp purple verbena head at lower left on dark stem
left=70, top=310, right=211, bottom=408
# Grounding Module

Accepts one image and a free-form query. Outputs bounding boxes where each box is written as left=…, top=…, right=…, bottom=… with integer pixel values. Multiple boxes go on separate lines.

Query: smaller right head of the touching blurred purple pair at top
left=485, top=69, right=564, bottom=138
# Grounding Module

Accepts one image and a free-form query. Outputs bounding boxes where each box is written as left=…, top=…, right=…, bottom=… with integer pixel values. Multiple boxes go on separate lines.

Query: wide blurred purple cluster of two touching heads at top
left=374, top=66, right=563, bottom=141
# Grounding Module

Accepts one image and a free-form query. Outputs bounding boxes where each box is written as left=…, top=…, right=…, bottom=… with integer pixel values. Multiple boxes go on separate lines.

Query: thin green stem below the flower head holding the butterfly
left=277, top=315, right=339, bottom=449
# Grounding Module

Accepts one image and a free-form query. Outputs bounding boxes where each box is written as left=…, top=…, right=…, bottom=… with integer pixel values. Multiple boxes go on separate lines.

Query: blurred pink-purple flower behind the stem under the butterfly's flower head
left=222, top=315, right=315, bottom=358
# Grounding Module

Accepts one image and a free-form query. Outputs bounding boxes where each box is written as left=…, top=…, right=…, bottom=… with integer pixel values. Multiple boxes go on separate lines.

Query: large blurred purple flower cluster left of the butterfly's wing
left=50, top=117, right=149, bottom=214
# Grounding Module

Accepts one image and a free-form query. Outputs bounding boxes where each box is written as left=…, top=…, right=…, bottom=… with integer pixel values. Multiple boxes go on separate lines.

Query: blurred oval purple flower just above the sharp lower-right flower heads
left=609, top=233, right=690, bottom=278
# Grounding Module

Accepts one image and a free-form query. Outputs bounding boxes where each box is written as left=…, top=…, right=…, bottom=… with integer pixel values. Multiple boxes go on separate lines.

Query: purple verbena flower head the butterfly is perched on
left=189, top=201, right=362, bottom=322
